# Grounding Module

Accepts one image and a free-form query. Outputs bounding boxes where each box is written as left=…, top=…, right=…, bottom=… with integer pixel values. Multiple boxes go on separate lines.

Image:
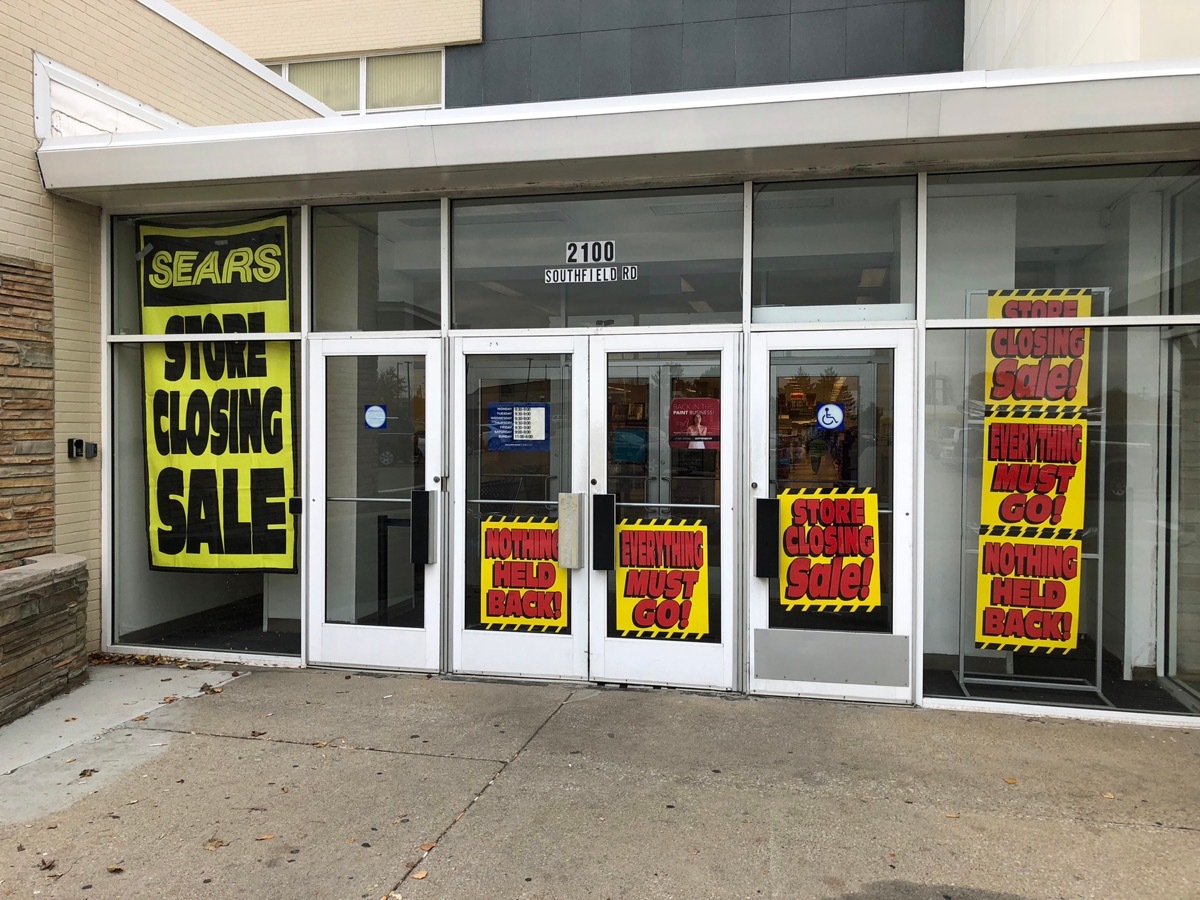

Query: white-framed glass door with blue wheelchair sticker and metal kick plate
left=746, top=331, right=912, bottom=702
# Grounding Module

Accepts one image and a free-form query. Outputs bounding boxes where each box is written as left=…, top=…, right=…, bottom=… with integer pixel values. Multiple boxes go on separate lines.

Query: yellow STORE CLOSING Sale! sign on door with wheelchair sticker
left=779, top=488, right=882, bottom=612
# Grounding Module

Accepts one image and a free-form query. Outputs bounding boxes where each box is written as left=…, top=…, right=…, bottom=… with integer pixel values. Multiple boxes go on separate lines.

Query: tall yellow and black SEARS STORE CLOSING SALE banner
left=138, top=216, right=296, bottom=572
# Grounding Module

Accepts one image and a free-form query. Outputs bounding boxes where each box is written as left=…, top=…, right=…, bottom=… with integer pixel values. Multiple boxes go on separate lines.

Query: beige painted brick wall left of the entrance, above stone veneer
left=0, top=0, right=316, bottom=648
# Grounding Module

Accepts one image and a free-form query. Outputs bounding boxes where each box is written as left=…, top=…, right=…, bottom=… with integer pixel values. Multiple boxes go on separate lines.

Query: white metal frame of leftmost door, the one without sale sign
left=305, top=337, right=445, bottom=672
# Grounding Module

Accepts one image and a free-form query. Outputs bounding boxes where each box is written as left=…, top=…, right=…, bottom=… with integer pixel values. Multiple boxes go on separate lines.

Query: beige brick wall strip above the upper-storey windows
left=174, top=0, right=484, bottom=60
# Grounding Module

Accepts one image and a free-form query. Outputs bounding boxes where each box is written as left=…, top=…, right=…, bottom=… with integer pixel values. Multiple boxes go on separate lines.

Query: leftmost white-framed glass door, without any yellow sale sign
left=307, top=338, right=444, bottom=671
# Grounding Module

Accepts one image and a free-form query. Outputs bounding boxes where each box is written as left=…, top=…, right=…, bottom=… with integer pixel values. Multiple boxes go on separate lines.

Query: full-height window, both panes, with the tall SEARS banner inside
left=110, top=212, right=301, bottom=655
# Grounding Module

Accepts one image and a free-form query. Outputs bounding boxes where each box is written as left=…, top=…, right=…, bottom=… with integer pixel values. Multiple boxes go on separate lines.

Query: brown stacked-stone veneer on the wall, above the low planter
left=0, top=256, right=54, bottom=569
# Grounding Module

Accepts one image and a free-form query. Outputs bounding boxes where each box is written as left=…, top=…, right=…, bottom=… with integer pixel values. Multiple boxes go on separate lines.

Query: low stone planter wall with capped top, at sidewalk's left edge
left=0, top=553, right=88, bottom=725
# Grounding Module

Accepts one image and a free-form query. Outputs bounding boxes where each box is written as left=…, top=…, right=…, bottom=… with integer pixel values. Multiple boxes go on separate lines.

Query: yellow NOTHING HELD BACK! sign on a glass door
left=479, top=517, right=570, bottom=631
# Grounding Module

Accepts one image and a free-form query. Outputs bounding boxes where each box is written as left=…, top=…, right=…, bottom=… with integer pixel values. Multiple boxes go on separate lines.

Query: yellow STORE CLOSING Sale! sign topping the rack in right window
left=984, top=290, right=1092, bottom=407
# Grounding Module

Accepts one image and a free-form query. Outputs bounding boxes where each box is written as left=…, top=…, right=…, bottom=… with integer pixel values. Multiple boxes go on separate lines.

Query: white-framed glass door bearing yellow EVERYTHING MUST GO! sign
left=589, top=334, right=742, bottom=689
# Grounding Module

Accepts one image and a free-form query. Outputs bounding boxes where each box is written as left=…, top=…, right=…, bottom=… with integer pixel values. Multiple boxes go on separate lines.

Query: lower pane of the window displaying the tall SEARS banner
left=112, top=342, right=300, bottom=655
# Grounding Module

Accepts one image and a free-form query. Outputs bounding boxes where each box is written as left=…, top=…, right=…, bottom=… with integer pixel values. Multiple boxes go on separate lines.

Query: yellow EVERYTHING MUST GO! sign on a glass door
left=616, top=520, right=710, bottom=641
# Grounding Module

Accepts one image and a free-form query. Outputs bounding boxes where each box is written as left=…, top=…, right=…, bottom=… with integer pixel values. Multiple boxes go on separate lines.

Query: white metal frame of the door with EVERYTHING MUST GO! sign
left=589, top=331, right=744, bottom=690
